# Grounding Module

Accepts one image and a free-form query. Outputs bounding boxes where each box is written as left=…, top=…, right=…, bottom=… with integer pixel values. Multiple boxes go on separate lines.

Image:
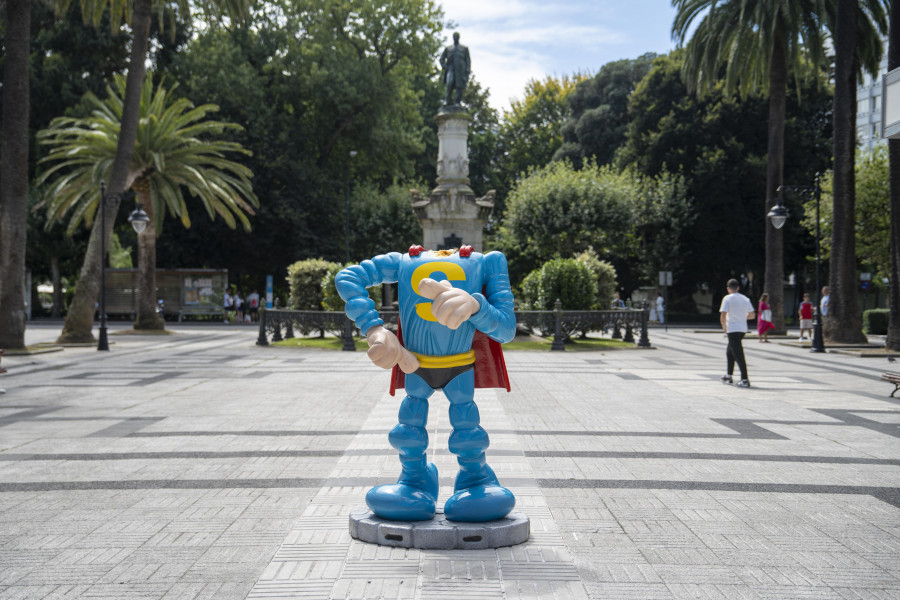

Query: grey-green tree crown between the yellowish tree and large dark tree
left=554, top=53, right=656, bottom=167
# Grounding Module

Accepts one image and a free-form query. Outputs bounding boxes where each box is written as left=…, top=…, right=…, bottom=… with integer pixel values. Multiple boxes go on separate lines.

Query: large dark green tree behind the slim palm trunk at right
left=618, top=52, right=831, bottom=297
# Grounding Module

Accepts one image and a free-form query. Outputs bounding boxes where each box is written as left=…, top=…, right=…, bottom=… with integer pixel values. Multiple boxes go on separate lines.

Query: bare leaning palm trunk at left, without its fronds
left=57, top=0, right=151, bottom=343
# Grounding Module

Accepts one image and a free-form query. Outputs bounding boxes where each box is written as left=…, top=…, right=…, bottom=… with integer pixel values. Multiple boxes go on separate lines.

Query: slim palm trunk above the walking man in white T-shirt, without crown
left=763, top=28, right=787, bottom=333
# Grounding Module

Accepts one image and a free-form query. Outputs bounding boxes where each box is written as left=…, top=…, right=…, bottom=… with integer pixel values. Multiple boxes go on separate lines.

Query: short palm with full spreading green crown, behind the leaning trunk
left=38, top=74, right=259, bottom=329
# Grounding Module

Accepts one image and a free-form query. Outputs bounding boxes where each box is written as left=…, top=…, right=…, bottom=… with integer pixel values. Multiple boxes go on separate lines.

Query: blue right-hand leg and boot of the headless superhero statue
left=444, top=370, right=516, bottom=522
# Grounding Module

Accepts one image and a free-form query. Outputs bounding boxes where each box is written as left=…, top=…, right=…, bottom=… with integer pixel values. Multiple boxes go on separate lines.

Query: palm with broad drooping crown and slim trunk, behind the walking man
left=672, top=0, right=833, bottom=332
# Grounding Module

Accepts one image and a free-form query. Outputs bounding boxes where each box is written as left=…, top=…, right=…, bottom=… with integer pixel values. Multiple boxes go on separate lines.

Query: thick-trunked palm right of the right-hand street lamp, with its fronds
left=823, top=0, right=890, bottom=343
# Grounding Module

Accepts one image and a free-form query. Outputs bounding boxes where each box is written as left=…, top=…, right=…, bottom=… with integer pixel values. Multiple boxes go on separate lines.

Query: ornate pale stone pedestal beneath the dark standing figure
left=412, top=106, right=494, bottom=252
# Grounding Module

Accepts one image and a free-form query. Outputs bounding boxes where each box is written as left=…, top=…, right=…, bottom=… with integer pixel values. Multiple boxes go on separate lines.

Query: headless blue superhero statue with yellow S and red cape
left=335, top=246, right=516, bottom=522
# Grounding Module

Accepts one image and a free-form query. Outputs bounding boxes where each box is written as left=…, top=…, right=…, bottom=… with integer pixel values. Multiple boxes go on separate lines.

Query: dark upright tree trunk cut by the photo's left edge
left=0, top=0, right=31, bottom=348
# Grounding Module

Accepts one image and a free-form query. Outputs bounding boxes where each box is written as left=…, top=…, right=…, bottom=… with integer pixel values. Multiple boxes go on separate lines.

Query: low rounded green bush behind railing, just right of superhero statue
left=522, top=258, right=597, bottom=310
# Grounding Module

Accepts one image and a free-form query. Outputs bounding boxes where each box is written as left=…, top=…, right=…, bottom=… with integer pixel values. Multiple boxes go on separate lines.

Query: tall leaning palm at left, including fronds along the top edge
left=52, top=0, right=253, bottom=343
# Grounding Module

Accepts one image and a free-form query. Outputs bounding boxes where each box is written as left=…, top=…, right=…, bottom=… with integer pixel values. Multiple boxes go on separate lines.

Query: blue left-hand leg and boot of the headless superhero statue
left=366, top=374, right=438, bottom=521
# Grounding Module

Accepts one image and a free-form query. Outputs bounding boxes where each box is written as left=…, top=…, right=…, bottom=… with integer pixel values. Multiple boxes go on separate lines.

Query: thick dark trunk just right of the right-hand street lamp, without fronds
left=824, top=0, right=866, bottom=344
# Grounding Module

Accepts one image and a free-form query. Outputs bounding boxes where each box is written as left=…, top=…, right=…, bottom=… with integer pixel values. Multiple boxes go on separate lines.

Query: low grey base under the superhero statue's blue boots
left=350, top=509, right=531, bottom=550
